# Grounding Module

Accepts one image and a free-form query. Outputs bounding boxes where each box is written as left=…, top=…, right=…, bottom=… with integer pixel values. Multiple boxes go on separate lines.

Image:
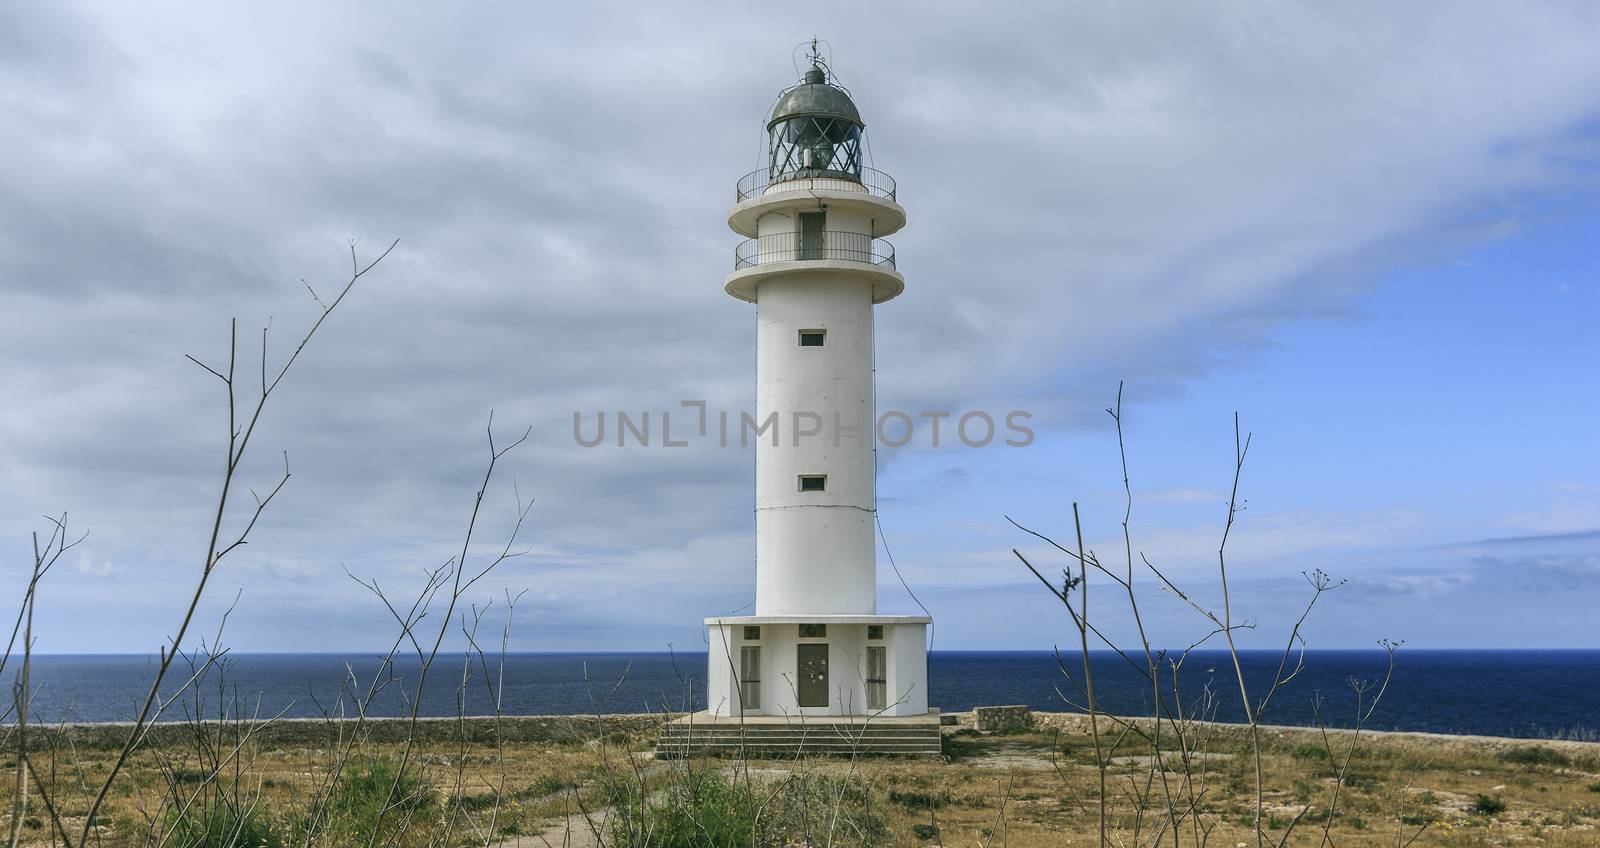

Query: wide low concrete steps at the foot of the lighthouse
left=656, top=717, right=941, bottom=757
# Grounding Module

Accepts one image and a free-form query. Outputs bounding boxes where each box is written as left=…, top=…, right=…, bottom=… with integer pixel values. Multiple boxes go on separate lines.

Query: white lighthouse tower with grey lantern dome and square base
left=706, top=50, right=938, bottom=720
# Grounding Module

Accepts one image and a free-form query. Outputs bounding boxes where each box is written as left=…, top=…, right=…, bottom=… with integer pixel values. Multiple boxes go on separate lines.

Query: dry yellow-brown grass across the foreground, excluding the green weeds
left=6, top=716, right=1600, bottom=848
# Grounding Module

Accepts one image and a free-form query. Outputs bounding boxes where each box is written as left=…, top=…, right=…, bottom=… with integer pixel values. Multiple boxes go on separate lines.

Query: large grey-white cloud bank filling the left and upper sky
left=0, top=3, right=1600, bottom=650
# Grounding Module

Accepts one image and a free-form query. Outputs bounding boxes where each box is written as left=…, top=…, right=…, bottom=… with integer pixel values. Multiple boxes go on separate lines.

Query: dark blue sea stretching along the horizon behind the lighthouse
left=8, top=650, right=1600, bottom=738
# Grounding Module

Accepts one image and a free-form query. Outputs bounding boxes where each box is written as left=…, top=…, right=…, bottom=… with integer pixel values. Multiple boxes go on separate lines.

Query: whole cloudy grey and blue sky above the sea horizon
left=0, top=3, right=1600, bottom=653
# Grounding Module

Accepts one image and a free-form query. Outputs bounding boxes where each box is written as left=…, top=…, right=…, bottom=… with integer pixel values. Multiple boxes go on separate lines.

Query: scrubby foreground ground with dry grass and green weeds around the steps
left=6, top=715, right=1600, bottom=848
